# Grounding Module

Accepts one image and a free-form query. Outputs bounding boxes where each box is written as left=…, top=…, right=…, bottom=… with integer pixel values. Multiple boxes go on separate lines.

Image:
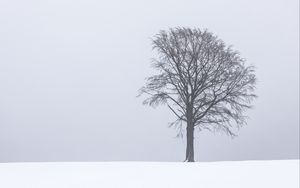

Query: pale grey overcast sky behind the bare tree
left=0, top=0, right=299, bottom=162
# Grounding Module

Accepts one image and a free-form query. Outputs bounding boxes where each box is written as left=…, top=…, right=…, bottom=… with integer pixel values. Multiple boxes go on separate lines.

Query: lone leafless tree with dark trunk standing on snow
left=140, top=28, right=256, bottom=162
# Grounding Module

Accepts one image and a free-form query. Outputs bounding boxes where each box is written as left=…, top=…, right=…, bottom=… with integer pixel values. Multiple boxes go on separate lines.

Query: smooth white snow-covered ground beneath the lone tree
left=0, top=160, right=299, bottom=188
